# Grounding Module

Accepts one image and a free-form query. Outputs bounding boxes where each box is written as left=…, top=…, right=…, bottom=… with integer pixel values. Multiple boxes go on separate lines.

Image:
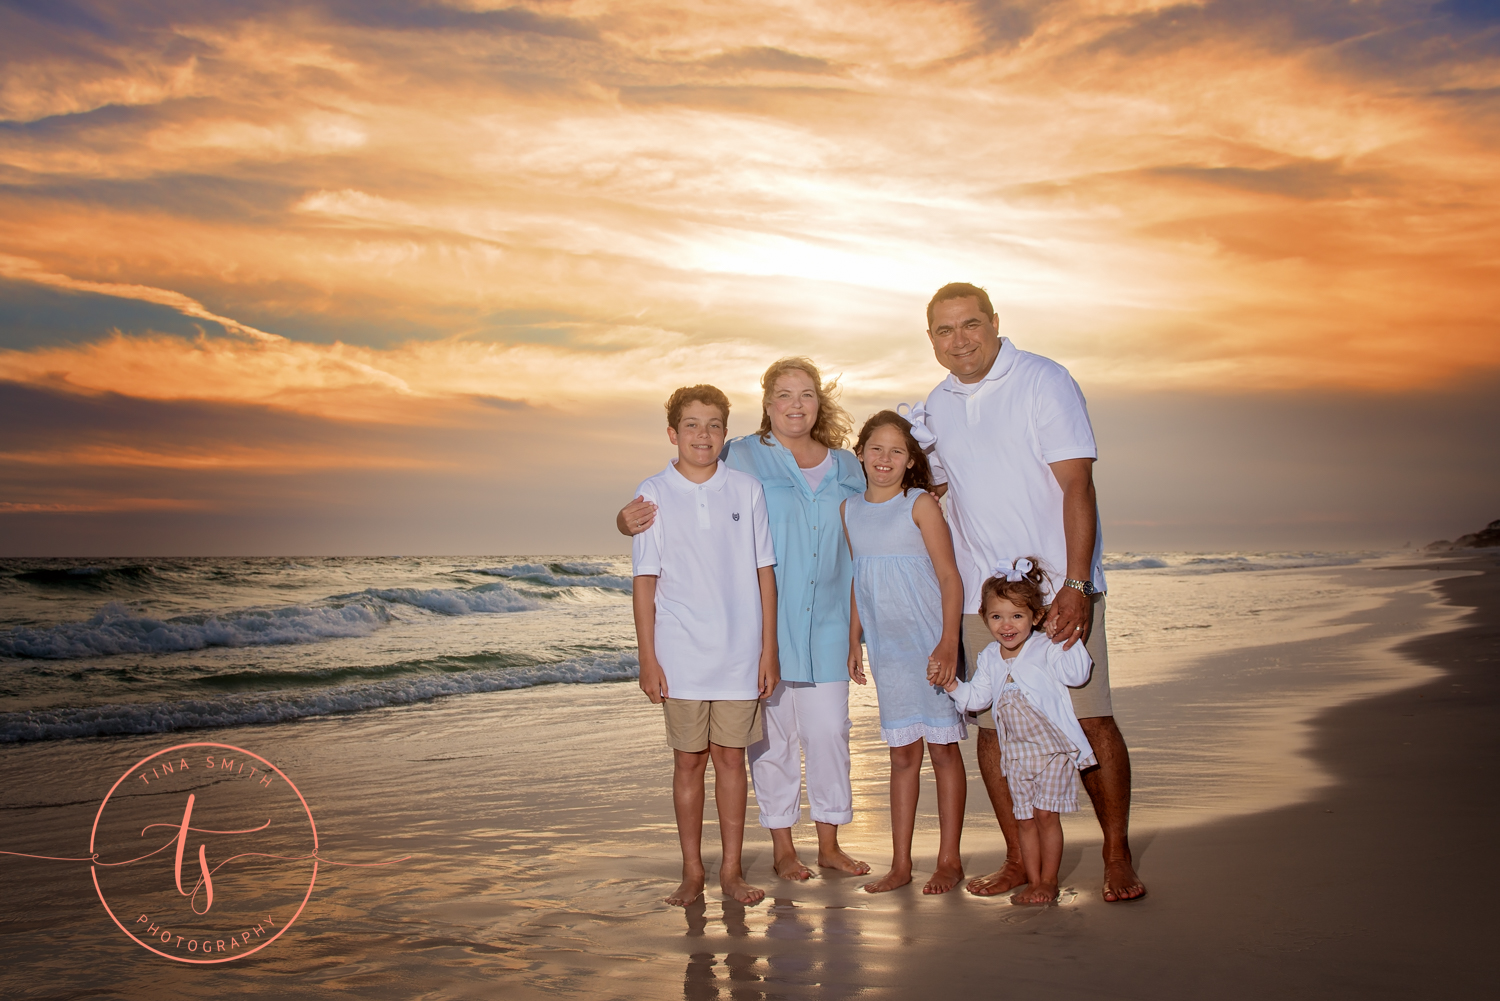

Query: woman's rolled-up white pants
left=749, top=681, right=854, bottom=830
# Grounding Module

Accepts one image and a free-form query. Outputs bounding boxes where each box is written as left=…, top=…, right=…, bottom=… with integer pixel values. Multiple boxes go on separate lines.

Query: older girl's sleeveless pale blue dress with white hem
left=845, top=489, right=969, bottom=747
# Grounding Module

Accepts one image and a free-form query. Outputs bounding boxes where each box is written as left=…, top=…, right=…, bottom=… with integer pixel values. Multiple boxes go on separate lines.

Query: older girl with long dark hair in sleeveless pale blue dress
left=842, top=410, right=968, bottom=893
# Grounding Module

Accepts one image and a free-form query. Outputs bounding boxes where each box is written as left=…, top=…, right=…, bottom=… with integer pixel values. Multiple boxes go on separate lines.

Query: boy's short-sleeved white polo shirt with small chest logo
left=630, top=459, right=776, bottom=699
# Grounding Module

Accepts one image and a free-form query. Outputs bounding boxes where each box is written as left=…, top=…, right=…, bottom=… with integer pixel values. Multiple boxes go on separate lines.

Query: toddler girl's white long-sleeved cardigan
left=950, top=630, right=1094, bottom=765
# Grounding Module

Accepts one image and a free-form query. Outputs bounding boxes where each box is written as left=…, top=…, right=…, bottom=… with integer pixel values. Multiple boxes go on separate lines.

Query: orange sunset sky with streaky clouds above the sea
left=0, top=0, right=1500, bottom=555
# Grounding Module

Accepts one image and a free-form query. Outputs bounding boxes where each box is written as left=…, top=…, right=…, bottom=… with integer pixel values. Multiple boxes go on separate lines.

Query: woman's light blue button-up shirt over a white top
left=723, top=435, right=864, bottom=681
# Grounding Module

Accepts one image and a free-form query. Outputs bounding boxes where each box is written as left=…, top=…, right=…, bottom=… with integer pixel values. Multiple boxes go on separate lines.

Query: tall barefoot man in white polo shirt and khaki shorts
left=926, top=282, right=1146, bottom=902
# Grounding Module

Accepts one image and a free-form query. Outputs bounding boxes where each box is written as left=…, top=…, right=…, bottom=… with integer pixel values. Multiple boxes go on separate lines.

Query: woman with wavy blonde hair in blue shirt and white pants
left=617, top=357, right=870, bottom=879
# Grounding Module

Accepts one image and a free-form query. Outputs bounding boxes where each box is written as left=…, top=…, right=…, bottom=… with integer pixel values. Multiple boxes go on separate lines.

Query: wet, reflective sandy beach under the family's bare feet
left=0, top=554, right=1500, bottom=999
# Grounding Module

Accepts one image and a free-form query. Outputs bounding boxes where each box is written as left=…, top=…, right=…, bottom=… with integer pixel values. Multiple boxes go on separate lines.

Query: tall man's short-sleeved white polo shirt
left=927, top=338, right=1104, bottom=612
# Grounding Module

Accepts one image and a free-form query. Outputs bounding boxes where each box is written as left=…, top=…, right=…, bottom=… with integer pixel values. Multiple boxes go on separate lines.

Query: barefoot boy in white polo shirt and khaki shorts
left=630, top=386, right=780, bottom=906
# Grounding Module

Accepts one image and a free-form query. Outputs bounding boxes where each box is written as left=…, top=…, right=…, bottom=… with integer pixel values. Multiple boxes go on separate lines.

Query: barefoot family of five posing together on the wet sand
left=617, top=284, right=1146, bottom=905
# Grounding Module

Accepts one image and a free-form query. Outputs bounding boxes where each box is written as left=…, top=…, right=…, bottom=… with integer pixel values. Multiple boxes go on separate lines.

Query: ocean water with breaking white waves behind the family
left=0, top=552, right=1386, bottom=744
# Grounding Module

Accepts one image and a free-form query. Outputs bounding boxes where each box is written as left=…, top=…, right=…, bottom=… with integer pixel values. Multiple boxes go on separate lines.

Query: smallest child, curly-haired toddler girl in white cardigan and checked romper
left=929, top=558, right=1097, bottom=903
